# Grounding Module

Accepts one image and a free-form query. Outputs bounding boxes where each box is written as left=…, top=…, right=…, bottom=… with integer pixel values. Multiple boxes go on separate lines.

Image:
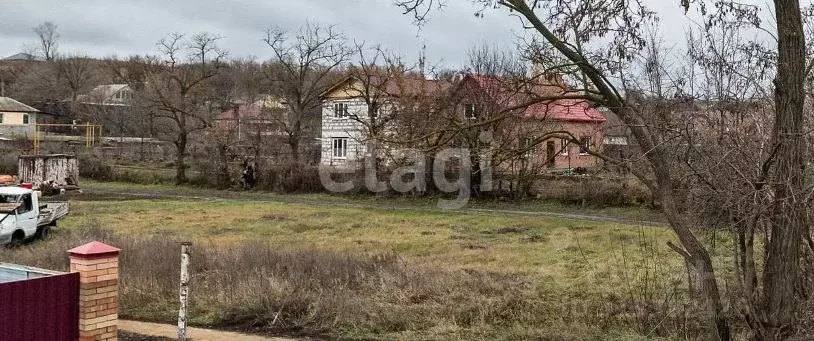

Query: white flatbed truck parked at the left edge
left=0, top=186, right=69, bottom=245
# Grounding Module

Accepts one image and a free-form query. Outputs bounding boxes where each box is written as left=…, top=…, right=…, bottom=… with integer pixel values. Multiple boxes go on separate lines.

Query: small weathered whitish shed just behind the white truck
left=17, top=154, right=79, bottom=188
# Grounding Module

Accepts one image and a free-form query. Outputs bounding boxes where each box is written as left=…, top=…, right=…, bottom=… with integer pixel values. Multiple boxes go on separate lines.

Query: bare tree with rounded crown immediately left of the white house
left=263, top=23, right=353, bottom=164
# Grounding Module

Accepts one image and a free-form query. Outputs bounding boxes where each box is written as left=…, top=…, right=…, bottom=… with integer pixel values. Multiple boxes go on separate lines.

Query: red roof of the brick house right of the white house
left=466, top=74, right=606, bottom=123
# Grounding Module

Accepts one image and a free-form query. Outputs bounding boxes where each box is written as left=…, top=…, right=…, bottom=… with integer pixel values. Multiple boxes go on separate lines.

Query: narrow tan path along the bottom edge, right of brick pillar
left=119, top=320, right=305, bottom=341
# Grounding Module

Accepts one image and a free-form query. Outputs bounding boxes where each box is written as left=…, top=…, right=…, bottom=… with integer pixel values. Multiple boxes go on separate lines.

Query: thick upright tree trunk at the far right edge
left=760, top=0, right=806, bottom=340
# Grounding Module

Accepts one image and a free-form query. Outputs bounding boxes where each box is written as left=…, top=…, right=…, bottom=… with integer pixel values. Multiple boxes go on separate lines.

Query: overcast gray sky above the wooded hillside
left=0, top=0, right=700, bottom=66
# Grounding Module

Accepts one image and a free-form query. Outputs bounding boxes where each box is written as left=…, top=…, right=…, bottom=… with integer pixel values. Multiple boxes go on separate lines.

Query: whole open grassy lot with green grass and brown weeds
left=2, top=182, right=720, bottom=340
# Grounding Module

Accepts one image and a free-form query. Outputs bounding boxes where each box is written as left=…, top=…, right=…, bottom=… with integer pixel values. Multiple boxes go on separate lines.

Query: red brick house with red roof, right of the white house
left=457, top=74, right=606, bottom=172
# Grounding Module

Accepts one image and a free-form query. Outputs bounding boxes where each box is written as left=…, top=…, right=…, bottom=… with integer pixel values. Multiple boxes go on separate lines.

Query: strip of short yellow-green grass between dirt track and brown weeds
left=62, top=195, right=682, bottom=292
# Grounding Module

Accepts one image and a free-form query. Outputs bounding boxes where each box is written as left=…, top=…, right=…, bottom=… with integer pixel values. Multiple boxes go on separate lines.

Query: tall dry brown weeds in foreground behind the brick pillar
left=0, top=222, right=728, bottom=340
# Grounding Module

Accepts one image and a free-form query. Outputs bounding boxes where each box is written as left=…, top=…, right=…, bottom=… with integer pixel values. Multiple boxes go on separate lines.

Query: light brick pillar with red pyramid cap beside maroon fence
left=68, top=242, right=121, bottom=341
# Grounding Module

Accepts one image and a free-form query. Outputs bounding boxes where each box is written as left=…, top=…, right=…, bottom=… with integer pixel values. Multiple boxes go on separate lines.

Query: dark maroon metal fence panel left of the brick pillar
left=0, top=273, right=79, bottom=341
